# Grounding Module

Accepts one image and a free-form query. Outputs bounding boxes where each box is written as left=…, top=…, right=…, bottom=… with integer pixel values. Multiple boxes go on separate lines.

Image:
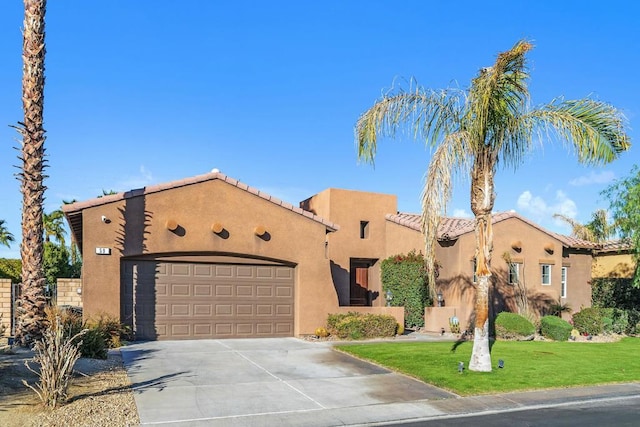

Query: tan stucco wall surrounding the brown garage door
left=83, top=180, right=338, bottom=335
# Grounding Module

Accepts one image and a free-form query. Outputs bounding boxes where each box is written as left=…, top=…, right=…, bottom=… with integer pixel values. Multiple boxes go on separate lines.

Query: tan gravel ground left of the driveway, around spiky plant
left=0, top=346, right=140, bottom=427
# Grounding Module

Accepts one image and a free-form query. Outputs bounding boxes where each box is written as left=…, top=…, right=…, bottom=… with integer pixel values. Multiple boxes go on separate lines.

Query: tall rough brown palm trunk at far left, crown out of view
left=16, top=0, right=46, bottom=345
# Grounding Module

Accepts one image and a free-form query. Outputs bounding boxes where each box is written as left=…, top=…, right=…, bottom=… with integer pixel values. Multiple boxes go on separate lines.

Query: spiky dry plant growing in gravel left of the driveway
left=22, top=318, right=86, bottom=408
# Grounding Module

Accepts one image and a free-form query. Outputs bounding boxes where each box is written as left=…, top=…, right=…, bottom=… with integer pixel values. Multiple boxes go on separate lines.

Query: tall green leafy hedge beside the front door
left=381, top=251, right=431, bottom=327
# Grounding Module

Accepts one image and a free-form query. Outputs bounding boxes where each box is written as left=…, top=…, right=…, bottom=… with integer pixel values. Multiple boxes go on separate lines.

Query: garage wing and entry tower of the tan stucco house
left=63, top=172, right=404, bottom=339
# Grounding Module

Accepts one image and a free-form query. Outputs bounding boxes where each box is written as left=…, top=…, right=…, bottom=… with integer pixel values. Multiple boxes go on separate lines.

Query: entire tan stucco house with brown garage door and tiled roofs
left=63, top=171, right=608, bottom=339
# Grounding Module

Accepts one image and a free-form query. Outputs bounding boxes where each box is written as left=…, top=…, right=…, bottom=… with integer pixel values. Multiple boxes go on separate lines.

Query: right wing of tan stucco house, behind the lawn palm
left=387, top=212, right=598, bottom=331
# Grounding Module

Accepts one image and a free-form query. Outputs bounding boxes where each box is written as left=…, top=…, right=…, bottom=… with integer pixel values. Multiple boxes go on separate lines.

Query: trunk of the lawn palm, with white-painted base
left=469, top=152, right=495, bottom=372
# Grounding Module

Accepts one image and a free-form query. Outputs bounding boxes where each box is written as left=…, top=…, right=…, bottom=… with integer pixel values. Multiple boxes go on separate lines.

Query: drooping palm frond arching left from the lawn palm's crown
left=355, top=87, right=461, bottom=163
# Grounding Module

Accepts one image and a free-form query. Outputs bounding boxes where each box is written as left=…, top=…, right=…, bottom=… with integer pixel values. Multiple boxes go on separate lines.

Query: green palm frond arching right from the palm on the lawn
left=529, top=98, right=631, bottom=164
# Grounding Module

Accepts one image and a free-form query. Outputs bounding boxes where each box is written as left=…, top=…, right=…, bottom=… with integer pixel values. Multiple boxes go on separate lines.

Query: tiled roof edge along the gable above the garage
left=62, top=171, right=340, bottom=248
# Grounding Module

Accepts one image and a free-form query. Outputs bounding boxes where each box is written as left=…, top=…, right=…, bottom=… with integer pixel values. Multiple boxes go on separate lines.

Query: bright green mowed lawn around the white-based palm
left=336, top=338, right=640, bottom=396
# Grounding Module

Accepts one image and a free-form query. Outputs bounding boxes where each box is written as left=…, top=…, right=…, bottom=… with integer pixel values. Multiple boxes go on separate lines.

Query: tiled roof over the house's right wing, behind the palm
left=386, top=212, right=603, bottom=249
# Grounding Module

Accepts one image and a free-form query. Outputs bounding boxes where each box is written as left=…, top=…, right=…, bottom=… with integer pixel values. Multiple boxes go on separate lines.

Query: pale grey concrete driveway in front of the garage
left=121, top=338, right=454, bottom=426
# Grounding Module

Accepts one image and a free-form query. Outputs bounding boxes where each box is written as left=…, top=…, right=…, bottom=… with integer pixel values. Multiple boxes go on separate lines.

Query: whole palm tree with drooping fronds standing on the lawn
left=355, top=40, right=630, bottom=371
